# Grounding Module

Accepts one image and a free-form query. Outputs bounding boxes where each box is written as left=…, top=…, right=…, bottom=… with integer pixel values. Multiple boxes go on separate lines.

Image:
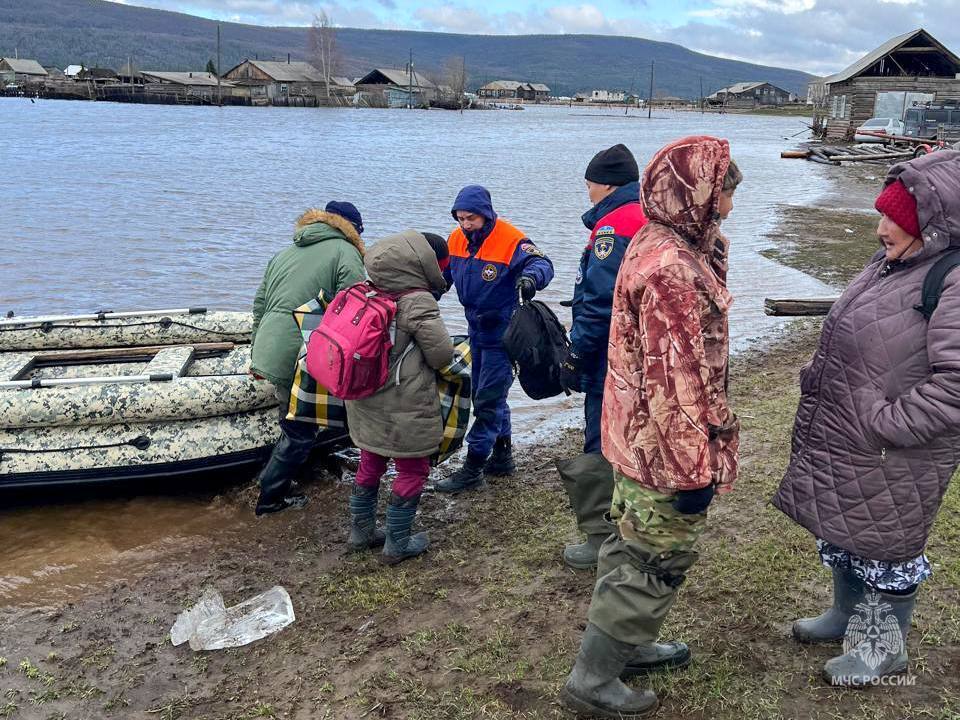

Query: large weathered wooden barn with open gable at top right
left=820, top=28, right=960, bottom=139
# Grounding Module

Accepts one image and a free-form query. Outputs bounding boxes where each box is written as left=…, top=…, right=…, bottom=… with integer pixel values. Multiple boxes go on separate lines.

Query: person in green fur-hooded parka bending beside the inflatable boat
left=250, top=201, right=365, bottom=515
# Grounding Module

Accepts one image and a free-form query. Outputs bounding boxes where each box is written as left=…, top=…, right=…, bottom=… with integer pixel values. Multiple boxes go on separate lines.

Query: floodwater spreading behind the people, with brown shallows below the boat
left=0, top=98, right=830, bottom=605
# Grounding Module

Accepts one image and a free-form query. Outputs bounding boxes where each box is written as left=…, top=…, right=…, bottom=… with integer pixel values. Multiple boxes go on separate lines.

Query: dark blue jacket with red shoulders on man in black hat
left=570, top=182, right=647, bottom=392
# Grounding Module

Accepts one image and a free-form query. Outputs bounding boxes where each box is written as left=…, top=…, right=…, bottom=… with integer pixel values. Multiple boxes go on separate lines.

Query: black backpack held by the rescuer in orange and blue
left=503, top=300, right=570, bottom=400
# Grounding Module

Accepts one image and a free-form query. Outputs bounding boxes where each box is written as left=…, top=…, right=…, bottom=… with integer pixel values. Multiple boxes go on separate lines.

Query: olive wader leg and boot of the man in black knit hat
left=557, top=453, right=616, bottom=570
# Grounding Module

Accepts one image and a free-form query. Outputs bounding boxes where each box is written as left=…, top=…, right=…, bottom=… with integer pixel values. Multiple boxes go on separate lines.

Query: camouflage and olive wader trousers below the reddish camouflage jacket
left=587, top=473, right=707, bottom=645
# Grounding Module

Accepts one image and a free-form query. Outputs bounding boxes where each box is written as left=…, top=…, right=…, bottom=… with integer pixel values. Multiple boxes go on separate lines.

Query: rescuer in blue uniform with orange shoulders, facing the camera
left=435, top=185, right=553, bottom=493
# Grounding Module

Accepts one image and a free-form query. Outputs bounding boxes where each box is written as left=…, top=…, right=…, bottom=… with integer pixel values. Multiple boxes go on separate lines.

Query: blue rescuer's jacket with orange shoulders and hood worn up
left=444, top=185, right=553, bottom=347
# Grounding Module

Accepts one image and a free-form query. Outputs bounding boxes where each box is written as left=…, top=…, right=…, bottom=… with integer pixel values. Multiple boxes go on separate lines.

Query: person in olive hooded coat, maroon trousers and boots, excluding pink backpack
left=336, top=230, right=453, bottom=565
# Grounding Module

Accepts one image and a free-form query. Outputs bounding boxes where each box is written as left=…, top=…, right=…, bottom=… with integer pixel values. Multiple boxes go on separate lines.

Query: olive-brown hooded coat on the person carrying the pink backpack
left=346, top=230, right=453, bottom=458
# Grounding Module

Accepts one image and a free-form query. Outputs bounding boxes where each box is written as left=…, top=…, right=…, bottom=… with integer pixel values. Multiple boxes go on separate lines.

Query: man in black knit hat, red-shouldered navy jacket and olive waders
left=557, top=145, right=647, bottom=570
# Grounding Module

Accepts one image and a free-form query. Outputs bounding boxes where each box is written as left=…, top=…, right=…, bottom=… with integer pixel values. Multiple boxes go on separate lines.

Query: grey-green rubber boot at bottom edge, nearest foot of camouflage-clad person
left=560, top=623, right=659, bottom=720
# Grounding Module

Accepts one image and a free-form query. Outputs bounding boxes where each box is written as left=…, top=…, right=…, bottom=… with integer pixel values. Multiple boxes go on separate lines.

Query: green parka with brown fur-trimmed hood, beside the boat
left=250, top=210, right=364, bottom=391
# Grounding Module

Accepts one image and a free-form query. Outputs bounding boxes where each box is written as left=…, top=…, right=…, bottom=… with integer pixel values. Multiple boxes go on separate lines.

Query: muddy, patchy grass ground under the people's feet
left=0, top=165, right=960, bottom=720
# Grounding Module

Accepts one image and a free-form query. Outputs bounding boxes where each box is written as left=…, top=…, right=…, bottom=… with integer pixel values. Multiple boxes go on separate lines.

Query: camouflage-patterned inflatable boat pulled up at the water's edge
left=0, top=308, right=342, bottom=488
